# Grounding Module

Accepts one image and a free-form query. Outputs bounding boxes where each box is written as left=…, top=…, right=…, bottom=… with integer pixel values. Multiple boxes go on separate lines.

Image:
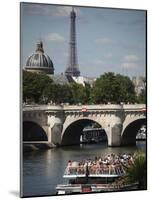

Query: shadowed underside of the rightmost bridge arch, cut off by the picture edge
left=121, top=117, right=146, bottom=146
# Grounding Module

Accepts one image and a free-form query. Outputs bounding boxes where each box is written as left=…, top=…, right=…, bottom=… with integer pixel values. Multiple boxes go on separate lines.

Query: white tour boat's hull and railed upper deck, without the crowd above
left=56, top=158, right=138, bottom=195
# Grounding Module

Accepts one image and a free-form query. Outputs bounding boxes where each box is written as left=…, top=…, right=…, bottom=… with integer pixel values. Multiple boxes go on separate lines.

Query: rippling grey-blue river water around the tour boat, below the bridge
left=23, top=141, right=146, bottom=197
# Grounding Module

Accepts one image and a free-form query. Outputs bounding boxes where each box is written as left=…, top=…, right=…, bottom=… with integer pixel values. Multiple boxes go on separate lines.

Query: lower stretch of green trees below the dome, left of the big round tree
left=23, top=71, right=90, bottom=104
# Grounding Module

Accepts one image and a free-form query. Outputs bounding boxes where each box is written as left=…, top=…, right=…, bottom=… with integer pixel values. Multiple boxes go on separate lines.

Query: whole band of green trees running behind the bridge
left=23, top=71, right=140, bottom=104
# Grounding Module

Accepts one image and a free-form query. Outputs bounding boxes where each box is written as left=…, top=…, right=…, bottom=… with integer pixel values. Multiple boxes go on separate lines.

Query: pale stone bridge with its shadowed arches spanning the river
left=23, top=104, right=146, bottom=146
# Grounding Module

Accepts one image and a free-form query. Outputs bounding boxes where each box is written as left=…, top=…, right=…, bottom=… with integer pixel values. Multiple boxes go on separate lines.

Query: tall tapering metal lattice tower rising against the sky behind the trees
left=65, top=8, right=80, bottom=77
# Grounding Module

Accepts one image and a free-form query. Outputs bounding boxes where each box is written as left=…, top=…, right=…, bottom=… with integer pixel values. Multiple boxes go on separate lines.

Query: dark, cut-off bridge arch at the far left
left=23, top=121, right=48, bottom=141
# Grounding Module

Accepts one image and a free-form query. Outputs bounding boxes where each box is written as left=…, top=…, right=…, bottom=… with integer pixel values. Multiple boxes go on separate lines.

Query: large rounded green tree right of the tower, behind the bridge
left=91, top=72, right=136, bottom=103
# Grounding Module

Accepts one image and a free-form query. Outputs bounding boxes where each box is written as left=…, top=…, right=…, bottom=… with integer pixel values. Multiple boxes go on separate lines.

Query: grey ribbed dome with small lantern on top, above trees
left=25, top=41, right=54, bottom=74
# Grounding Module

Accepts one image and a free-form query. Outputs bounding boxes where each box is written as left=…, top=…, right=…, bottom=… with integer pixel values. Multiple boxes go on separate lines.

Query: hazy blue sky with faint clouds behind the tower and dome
left=21, top=3, right=146, bottom=77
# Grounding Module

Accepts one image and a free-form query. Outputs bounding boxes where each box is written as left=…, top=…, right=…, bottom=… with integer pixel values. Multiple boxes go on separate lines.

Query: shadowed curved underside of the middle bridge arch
left=61, top=118, right=108, bottom=145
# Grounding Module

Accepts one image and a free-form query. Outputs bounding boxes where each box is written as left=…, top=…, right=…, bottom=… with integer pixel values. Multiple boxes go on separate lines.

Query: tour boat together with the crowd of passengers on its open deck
left=56, top=154, right=137, bottom=194
